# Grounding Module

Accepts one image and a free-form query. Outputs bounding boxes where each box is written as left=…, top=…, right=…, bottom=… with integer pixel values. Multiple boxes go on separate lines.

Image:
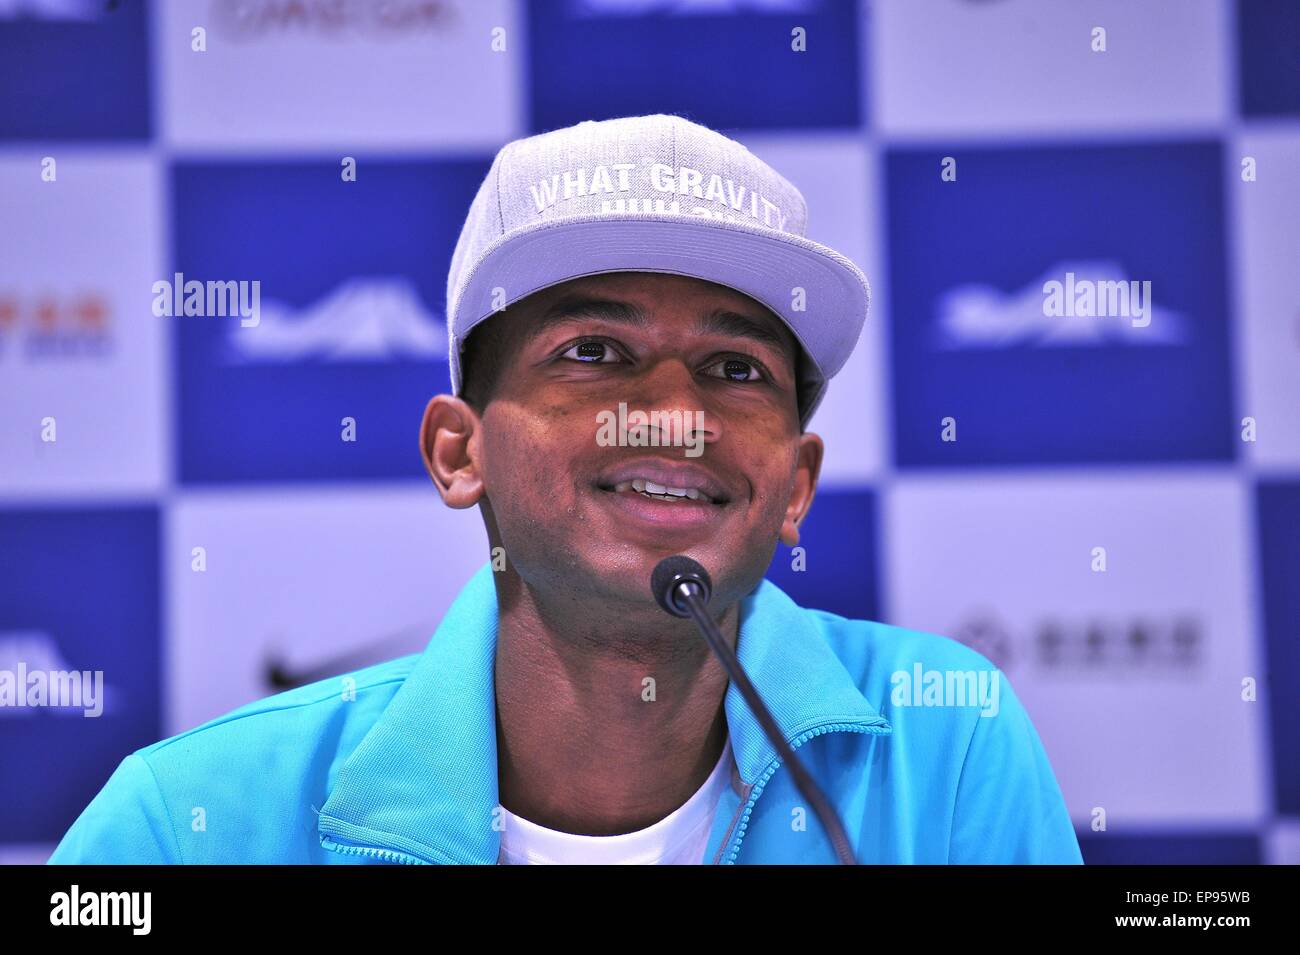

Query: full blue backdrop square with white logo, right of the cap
left=885, top=142, right=1238, bottom=468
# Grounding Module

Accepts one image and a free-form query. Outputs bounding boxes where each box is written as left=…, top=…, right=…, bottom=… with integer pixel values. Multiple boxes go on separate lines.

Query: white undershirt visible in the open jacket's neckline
left=497, top=739, right=732, bottom=865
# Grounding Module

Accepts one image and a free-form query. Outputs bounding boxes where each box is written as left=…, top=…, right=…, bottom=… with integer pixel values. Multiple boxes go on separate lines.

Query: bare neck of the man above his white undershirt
left=494, top=570, right=740, bottom=835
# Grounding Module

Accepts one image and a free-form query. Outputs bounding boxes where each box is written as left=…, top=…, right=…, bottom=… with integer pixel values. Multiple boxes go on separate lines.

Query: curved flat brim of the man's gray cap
left=447, top=213, right=871, bottom=425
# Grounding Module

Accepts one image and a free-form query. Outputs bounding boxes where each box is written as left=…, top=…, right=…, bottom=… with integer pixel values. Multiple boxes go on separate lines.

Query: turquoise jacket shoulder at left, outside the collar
left=49, top=654, right=419, bottom=863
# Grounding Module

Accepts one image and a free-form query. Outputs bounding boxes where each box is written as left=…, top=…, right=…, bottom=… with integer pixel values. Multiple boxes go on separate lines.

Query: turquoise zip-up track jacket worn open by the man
left=49, top=563, right=1083, bottom=865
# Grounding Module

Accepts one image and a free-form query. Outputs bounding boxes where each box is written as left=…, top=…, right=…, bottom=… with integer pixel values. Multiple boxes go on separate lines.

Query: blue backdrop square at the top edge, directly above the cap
left=528, top=0, right=865, bottom=131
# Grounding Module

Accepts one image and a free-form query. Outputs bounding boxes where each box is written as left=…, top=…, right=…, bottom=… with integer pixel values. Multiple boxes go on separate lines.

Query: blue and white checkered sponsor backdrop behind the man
left=0, top=0, right=1300, bottom=863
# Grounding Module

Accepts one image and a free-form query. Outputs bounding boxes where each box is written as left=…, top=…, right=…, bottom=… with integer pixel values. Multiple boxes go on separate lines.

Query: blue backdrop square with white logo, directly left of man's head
left=172, top=157, right=489, bottom=483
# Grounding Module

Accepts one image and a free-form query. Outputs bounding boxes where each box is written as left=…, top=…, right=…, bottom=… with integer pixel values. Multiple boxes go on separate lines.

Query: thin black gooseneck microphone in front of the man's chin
left=650, top=554, right=858, bottom=865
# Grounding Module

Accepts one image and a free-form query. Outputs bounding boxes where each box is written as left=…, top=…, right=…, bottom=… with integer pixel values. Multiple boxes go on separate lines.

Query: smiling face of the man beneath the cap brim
left=424, top=273, right=822, bottom=602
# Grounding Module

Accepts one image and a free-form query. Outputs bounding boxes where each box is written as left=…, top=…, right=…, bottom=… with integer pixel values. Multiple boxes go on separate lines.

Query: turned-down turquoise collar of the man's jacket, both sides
left=319, top=561, right=892, bottom=863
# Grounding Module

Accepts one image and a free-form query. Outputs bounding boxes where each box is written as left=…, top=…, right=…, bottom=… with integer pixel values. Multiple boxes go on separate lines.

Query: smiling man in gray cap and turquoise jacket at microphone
left=51, top=114, right=1082, bottom=864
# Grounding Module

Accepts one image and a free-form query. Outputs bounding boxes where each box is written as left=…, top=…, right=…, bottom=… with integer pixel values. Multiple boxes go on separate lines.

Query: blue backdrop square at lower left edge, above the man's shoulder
left=0, top=507, right=163, bottom=843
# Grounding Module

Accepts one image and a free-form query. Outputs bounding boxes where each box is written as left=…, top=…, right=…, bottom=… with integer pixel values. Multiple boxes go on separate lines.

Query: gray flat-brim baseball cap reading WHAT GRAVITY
left=447, top=113, right=871, bottom=426
